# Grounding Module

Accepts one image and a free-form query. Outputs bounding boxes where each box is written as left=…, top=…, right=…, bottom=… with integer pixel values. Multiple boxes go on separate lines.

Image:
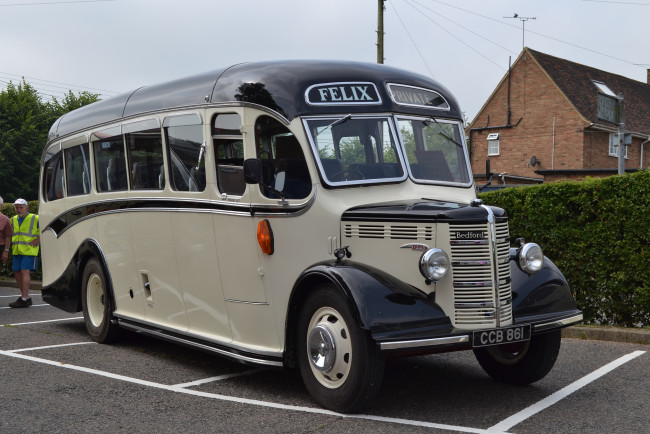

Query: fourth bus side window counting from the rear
left=124, top=128, right=165, bottom=190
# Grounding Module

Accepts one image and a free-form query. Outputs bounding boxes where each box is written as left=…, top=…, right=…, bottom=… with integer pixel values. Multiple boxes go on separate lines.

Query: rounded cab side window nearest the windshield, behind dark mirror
left=255, top=116, right=311, bottom=199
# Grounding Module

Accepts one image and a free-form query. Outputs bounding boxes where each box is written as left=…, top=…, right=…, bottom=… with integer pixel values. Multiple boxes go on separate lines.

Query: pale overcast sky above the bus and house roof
left=0, top=0, right=650, bottom=121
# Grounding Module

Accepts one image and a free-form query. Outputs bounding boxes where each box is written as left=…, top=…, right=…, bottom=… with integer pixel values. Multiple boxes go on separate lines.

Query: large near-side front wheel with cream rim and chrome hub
left=298, top=285, right=384, bottom=413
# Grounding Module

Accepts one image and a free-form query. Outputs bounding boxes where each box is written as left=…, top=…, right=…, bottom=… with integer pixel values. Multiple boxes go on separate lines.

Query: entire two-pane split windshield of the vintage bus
left=305, top=114, right=471, bottom=186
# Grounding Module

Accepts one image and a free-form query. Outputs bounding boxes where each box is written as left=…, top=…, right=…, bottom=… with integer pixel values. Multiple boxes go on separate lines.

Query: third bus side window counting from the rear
left=93, top=128, right=127, bottom=192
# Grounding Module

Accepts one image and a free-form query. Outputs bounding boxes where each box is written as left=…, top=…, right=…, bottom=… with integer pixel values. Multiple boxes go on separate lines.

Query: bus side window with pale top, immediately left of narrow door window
left=163, top=115, right=205, bottom=191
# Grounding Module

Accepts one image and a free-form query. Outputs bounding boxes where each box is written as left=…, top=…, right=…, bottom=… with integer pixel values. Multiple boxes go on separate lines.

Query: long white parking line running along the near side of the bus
left=0, top=350, right=495, bottom=433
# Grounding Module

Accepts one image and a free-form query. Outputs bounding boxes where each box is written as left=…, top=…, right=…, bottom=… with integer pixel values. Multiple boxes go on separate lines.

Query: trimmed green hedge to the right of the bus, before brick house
left=479, top=171, right=650, bottom=327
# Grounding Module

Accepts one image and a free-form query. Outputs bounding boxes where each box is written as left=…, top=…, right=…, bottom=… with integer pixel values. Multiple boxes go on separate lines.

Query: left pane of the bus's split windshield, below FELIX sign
left=305, top=115, right=406, bottom=185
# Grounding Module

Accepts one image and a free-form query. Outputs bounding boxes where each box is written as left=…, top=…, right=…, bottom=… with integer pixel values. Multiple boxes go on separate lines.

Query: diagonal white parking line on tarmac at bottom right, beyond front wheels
left=490, top=351, right=645, bottom=431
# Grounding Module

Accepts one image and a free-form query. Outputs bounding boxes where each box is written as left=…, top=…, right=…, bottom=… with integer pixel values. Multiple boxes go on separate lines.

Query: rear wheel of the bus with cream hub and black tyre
left=81, top=258, right=120, bottom=343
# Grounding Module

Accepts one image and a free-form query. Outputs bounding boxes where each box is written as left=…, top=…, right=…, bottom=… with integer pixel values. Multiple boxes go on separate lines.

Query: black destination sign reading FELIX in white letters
left=305, top=82, right=381, bottom=105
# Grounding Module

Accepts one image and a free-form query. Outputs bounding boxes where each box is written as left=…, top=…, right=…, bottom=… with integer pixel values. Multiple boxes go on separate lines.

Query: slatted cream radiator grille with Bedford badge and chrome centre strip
left=449, top=221, right=512, bottom=327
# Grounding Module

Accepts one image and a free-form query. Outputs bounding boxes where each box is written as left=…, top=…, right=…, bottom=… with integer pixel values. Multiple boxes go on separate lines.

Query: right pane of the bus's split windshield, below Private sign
left=398, top=119, right=470, bottom=184
